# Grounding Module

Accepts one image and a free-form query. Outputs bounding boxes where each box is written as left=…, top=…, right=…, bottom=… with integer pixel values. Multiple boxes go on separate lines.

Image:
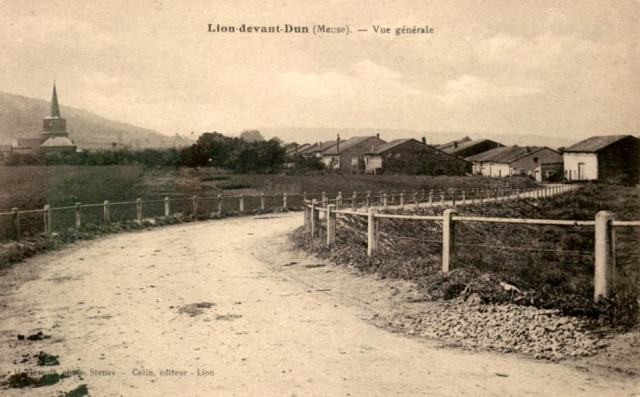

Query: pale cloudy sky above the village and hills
left=0, top=0, right=640, bottom=140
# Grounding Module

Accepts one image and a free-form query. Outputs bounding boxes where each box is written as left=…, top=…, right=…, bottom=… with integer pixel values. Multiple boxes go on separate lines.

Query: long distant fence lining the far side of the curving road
left=0, top=185, right=566, bottom=241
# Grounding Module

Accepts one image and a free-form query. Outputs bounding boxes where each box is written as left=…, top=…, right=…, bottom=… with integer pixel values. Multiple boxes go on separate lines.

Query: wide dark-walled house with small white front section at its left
left=364, top=138, right=471, bottom=175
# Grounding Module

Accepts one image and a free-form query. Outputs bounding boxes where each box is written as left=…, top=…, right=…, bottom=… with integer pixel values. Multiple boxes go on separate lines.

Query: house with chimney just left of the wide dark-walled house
left=322, top=134, right=385, bottom=174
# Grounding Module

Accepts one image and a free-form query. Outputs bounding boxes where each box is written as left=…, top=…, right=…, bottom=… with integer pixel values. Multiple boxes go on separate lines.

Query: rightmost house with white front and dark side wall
left=562, top=135, right=640, bottom=183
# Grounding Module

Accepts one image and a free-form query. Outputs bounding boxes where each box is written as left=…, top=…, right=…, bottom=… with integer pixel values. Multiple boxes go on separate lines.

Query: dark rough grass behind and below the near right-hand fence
left=296, top=185, right=640, bottom=325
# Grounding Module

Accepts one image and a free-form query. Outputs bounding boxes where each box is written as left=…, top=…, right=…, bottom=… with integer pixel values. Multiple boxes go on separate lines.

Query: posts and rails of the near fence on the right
left=304, top=185, right=640, bottom=300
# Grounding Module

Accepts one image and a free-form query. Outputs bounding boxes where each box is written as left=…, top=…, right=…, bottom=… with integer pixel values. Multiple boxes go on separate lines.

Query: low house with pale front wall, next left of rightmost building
left=466, top=146, right=562, bottom=178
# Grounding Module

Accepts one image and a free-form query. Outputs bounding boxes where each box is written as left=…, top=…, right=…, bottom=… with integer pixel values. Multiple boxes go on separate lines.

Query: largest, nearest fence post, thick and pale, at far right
left=593, top=211, right=616, bottom=301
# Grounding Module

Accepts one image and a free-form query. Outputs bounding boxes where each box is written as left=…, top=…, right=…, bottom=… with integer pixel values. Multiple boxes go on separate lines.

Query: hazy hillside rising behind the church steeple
left=0, top=92, right=193, bottom=149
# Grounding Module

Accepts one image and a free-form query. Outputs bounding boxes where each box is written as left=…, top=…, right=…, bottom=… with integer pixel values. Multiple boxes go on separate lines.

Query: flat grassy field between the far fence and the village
left=0, top=165, right=532, bottom=212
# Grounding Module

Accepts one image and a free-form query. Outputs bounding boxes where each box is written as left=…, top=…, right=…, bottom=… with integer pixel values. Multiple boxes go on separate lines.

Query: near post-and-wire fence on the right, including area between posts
left=305, top=186, right=640, bottom=299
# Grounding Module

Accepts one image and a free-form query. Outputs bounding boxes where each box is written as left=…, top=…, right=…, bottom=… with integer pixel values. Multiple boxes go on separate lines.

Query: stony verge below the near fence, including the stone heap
left=290, top=230, right=640, bottom=374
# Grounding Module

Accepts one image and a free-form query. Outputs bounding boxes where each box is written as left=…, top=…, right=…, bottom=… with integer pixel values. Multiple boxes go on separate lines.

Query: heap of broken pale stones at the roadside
left=384, top=301, right=607, bottom=360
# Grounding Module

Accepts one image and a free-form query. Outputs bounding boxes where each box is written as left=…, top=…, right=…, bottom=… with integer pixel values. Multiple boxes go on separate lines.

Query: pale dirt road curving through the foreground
left=0, top=214, right=638, bottom=396
